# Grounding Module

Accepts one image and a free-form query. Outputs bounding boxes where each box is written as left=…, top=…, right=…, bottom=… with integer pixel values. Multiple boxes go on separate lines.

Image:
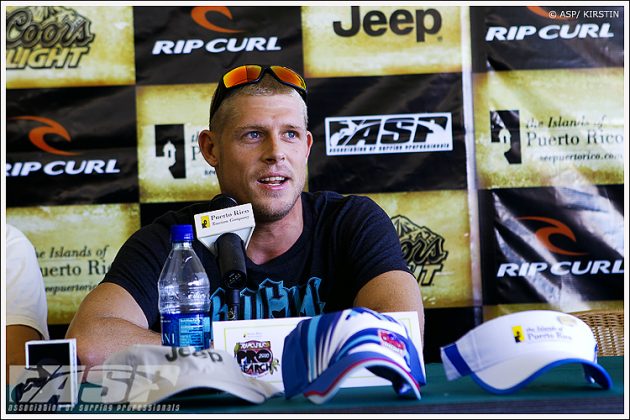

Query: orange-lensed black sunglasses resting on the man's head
left=210, top=64, right=306, bottom=126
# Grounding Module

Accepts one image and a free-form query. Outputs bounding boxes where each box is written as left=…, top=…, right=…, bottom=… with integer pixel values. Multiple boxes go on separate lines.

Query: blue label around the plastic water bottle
left=161, top=313, right=211, bottom=351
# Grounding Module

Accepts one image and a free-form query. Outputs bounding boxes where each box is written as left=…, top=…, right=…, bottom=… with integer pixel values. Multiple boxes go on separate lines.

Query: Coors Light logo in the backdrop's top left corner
left=6, top=6, right=94, bottom=70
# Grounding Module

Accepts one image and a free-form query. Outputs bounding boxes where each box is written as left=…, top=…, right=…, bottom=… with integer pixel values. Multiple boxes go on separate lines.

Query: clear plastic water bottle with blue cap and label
left=158, top=225, right=212, bottom=351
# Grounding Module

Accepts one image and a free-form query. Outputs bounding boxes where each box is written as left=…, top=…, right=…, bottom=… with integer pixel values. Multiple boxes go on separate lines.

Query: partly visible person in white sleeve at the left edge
left=6, top=223, right=49, bottom=381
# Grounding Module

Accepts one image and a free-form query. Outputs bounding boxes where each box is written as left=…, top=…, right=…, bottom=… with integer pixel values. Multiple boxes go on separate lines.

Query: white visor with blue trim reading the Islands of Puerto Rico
left=440, top=310, right=612, bottom=394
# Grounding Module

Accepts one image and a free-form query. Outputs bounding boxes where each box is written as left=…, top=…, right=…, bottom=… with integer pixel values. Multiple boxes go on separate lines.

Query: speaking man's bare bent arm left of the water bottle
left=66, top=283, right=161, bottom=369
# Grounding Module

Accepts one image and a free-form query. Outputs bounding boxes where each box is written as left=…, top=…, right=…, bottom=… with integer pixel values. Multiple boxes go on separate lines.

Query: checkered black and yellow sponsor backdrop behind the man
left=3, top=4, right=626, bottom=360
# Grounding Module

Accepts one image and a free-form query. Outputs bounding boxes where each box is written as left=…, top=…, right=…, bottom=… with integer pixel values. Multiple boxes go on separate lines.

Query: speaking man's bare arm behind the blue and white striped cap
left=354, top=270, right=424, bottom=342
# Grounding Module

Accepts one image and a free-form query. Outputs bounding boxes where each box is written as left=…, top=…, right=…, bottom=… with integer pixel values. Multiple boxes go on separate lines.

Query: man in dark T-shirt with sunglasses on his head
left=67, top=65, right=424, bottom=366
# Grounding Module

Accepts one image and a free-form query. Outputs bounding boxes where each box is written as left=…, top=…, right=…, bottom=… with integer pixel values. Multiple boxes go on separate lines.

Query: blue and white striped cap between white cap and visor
left=282, top=308, right=426, bottom=404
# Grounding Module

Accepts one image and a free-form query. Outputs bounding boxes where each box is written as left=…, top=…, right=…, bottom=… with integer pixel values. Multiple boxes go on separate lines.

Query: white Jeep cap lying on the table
left=102, top=344, right=282, bottom=404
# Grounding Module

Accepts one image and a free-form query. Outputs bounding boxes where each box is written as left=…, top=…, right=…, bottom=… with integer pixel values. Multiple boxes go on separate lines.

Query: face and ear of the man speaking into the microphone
left=200, top=95, right=313, bottom=222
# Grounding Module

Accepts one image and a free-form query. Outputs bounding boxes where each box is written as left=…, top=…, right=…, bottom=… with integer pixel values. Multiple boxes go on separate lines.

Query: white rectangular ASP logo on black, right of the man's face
left=325, top=113, right=453, bottom=156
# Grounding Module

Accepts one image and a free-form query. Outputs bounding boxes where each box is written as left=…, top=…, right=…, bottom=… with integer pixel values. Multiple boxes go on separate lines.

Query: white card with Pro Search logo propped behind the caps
left=212, top=311, right=424, bottom=391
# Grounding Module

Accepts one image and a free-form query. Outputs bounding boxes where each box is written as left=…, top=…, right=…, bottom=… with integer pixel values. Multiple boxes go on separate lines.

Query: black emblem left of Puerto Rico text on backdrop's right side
left=490, top=110, right=522, bottom=164
